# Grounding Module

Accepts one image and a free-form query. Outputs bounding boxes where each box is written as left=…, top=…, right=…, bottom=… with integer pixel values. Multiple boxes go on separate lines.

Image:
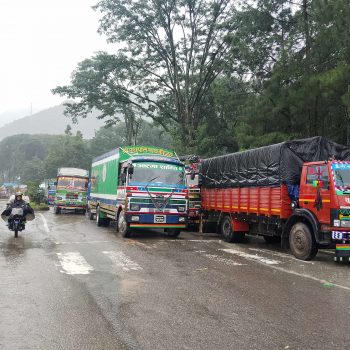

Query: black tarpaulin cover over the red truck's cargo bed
left=201, top=136, right=350, bottom=188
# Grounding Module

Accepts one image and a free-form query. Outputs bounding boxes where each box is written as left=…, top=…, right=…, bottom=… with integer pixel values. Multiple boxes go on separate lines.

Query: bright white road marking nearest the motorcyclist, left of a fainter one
left=56, top=252, right=94, bottom=275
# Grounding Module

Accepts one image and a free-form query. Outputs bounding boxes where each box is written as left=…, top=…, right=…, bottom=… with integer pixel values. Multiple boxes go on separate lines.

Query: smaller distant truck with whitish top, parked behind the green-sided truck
left=54, top=168, right=89, bottom=214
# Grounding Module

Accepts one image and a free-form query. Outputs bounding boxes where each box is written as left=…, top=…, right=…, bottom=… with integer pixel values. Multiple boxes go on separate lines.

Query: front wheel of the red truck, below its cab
left=289, top=222, right=318, bottom=260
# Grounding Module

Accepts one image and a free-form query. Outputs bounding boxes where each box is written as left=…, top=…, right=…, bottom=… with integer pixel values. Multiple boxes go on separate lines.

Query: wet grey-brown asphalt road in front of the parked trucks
left=0, top=204, right=350, bottom=350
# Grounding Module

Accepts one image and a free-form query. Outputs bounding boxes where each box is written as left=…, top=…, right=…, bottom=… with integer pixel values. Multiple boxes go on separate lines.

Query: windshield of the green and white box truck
left=129, top=162, right=185, bottom=186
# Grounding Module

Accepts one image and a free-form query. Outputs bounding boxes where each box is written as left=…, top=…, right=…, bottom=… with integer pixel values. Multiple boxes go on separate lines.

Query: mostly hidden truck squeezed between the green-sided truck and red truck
left=180, top=155, right=201, bottom=231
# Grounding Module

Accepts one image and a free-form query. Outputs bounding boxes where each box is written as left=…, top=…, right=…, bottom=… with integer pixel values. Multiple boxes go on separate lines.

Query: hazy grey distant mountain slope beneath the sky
left=0, top=105, right=104, bottom=141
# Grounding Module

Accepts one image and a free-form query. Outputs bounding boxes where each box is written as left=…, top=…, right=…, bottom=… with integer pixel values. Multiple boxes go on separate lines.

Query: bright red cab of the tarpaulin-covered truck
left=295, top=160, right=350, bottom=260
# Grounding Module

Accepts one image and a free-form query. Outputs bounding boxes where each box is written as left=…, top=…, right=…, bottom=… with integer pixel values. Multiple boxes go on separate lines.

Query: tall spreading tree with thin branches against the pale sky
left=53, top=0, right=235, bottom=151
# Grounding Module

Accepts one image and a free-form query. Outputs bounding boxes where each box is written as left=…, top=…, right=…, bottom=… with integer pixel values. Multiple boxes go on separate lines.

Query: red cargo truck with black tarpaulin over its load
left=201, top=137, right=350, bottom=261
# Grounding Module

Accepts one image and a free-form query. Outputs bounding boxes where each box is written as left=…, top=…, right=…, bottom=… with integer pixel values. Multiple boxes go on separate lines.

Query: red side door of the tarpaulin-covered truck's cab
left=299, top=165, right=331, bottom=224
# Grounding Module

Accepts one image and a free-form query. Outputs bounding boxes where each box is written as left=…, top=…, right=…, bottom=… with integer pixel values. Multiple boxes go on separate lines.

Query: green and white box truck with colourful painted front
left=89, top=146, right=188, bottom=237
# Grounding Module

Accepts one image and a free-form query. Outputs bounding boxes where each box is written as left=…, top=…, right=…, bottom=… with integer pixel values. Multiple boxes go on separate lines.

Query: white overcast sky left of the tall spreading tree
left=0, top=0, right=113, bottom=117
